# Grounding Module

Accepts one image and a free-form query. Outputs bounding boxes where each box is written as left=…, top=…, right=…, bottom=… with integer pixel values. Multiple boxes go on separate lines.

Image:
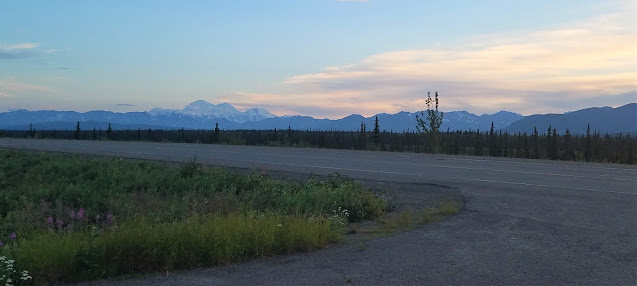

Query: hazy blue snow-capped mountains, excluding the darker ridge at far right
left=0, top=100, right=522, bottom=132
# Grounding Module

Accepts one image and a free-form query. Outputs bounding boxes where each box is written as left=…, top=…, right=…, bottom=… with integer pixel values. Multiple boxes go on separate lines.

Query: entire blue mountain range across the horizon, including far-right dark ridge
left=0, top=100, right=637, bottom=133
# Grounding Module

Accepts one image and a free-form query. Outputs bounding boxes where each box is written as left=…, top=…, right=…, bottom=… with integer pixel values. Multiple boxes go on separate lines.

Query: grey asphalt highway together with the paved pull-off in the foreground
left=0, top=138, right=637, bottom=285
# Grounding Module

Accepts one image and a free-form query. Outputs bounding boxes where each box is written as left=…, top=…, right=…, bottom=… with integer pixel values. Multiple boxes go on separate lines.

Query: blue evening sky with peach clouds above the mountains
left=0, top=0, right=637, bottom=119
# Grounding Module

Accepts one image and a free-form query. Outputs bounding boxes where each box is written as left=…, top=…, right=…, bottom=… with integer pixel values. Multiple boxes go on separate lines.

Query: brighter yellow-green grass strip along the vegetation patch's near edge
left=14, top=213, right=342, bottom=283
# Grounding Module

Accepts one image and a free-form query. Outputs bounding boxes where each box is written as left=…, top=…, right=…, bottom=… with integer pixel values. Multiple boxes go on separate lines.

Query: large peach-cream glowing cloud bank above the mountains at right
left=226, top=2, right=637, bottom=117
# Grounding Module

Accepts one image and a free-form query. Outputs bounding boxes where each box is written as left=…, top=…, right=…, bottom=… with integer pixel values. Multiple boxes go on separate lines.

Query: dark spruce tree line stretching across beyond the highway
left=0, top=118, right=637, bottom=164
